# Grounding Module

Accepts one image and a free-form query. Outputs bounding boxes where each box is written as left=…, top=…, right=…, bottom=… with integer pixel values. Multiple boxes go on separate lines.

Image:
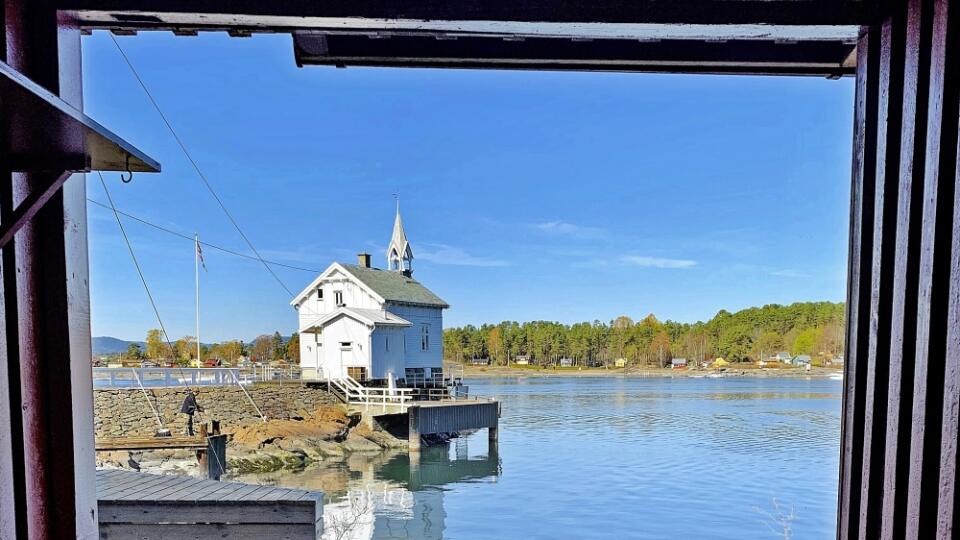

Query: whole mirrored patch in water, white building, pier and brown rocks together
left=241, top=438, right=500, bottom=540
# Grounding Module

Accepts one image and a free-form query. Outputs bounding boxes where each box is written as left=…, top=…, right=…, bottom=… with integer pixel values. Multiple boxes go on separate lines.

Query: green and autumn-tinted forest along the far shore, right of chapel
left=443, top=302, right=845, bottom=367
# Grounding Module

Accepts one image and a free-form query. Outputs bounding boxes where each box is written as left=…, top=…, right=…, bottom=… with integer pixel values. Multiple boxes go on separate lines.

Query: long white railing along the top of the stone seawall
left=93, top=368, right=253, bottom=388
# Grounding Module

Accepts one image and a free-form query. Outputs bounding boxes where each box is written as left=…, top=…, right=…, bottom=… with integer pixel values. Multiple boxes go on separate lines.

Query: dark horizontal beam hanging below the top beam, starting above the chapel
left=294, top=32, right=855, bottom=77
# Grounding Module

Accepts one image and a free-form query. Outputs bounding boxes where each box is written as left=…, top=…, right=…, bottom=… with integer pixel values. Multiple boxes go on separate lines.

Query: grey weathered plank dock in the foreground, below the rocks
left=97, top=469, right=323, bottom=540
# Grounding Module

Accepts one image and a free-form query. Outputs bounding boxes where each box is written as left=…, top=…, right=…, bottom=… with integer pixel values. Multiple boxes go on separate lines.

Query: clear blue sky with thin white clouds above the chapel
left=84, top=32, right=853, bottom=341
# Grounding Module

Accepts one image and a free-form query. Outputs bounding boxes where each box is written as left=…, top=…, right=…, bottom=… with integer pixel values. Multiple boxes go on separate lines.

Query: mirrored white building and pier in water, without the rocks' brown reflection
left=323, top=439, right=500, bottom=540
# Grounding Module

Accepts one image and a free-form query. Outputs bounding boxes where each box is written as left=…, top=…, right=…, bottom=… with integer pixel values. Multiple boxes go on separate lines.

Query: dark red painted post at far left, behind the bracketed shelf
left=5, top=0, right=85, bottom=538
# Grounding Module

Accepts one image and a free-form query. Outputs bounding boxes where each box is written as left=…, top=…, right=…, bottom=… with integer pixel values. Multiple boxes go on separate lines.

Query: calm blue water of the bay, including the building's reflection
left=242, top=378, right=841, bottom=540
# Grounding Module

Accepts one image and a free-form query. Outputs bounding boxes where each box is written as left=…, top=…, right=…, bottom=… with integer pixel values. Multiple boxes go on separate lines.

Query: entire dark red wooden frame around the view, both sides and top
left=0, top=0, right=960, bottom=540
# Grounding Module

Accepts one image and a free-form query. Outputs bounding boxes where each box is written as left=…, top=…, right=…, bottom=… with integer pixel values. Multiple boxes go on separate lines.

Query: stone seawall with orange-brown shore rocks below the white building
left=94, top=385, right=407, bottom=474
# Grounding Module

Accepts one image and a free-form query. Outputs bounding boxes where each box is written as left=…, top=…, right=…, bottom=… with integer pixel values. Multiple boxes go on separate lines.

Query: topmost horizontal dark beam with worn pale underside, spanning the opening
left=58, top=0, right=880, bottom=29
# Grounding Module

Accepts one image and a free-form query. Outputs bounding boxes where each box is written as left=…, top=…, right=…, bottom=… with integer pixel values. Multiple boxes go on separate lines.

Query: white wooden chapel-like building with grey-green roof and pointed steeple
left=290, top=208, right=450, bottom=386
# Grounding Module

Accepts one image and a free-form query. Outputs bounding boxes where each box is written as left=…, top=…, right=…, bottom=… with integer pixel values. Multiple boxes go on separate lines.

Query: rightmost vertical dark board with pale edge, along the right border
left=904, top=0, right=960, bottom=539
